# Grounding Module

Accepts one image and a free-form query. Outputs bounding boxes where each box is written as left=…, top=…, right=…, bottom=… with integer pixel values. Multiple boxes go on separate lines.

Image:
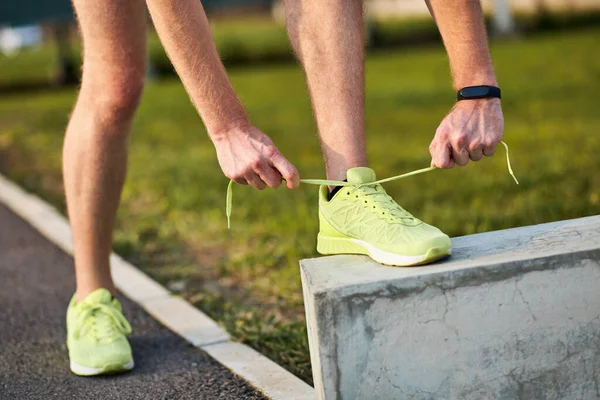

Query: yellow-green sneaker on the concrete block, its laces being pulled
left=317, top=167, right=452, bottom=266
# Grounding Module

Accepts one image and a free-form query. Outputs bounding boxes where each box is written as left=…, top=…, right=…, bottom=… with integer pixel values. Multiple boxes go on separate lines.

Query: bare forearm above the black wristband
left=426, top=0, right=497, bottom=90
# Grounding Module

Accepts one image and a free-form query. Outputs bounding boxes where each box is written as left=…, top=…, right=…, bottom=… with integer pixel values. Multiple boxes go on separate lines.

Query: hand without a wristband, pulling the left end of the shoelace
left=213, top=123, right=300, bottom=190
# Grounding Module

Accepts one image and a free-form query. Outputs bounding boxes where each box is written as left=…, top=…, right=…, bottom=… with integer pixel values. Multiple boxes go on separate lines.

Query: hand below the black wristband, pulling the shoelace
left=429, top=98, right=504, bottom=168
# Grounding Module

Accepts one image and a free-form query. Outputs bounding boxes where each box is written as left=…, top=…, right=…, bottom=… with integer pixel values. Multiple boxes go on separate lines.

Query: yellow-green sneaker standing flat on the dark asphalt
left=67, top=289, right=133, bottom=376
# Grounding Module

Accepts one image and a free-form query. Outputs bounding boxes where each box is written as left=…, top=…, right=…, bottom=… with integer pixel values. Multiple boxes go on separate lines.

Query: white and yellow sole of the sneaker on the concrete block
left=317, top=234, right=452, bottom=267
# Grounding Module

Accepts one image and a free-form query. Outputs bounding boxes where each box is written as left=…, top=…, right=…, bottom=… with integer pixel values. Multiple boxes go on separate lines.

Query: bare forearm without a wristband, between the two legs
left=147, top=0, right=247, bottom=140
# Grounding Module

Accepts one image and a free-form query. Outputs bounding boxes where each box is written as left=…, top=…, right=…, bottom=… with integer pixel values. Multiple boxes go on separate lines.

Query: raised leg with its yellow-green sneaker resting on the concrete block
left=285, top=0, right=451, bottom=266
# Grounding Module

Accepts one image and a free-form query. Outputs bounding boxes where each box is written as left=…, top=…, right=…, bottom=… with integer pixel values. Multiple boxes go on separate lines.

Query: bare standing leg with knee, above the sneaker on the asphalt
left=63, top=0, right=146, bottom=300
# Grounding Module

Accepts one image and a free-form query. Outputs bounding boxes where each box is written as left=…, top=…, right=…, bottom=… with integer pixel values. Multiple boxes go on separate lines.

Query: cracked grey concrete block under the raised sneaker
left=301, top=217, right=600, bottom=400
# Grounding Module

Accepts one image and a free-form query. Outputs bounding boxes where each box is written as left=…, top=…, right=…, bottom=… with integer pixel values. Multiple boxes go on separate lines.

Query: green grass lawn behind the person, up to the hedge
left=0, top=28, right=600, bottom=382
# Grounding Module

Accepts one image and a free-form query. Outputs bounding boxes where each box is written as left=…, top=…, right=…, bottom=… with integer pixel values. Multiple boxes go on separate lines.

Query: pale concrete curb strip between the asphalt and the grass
left=0, top=174, right=315, bottom=400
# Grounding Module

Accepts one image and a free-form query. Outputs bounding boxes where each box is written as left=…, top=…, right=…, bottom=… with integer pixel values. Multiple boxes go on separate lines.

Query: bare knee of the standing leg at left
left=80, top=67, right=144, bottom=125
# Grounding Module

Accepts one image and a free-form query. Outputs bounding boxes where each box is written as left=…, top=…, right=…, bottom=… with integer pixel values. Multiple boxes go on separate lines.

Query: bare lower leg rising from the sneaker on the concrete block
left=285, top=0, right=368, bottom=179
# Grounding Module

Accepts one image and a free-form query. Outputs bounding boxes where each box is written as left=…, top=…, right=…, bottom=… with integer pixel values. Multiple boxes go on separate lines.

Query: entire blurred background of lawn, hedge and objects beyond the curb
left=0, top=0, right=600, bottom=382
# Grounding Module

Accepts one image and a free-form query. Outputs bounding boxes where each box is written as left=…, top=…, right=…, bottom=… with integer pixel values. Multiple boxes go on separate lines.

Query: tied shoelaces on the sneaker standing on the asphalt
left=73, top=303, right=131, bottom=342
